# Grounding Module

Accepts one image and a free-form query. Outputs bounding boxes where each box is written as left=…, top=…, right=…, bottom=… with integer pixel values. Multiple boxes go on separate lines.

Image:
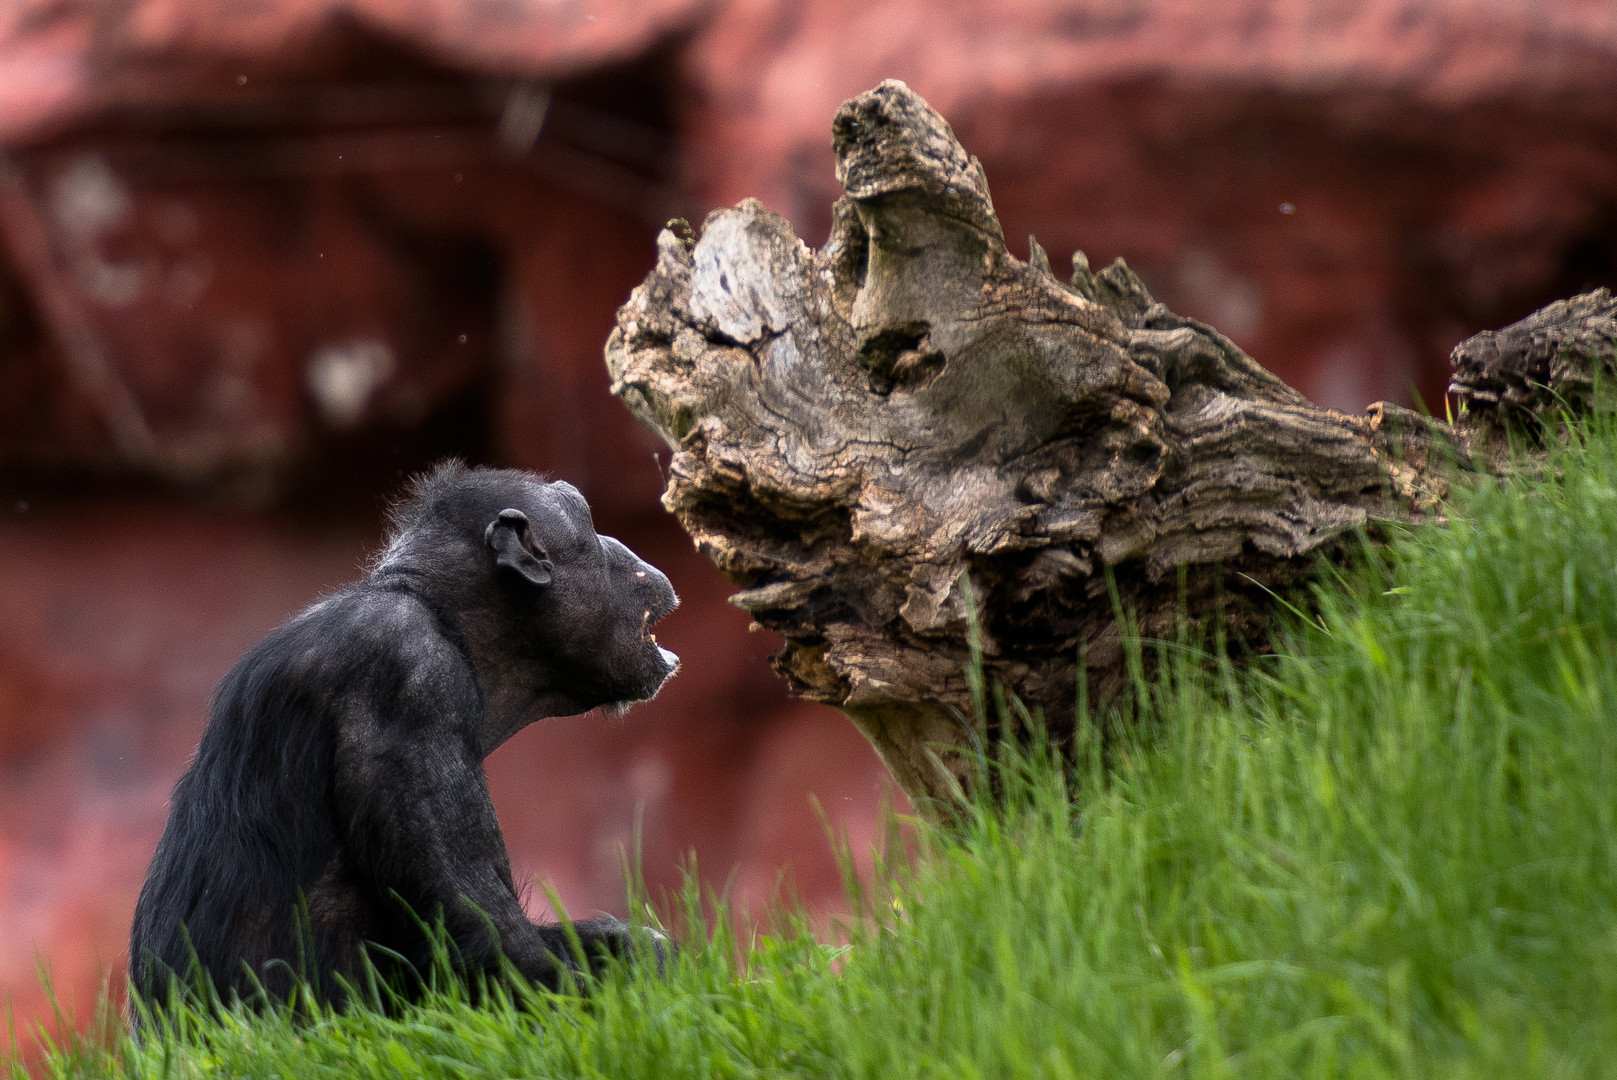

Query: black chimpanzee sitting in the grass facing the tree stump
left=129, top=462, right=679, bottom=1004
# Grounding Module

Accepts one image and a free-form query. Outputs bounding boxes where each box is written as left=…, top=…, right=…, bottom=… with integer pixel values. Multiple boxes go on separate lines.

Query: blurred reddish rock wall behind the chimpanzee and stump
left=0, top=0, right=1617, bottom=1038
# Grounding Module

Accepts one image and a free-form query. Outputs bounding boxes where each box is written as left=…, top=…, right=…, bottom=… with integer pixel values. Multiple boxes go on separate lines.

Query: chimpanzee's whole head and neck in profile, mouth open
left=374, top=462, right=679, bottom=749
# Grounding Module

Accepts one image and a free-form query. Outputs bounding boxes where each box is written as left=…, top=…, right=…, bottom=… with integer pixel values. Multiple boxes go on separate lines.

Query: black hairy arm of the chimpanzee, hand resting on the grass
left=333, top=627, right=627, bottom=986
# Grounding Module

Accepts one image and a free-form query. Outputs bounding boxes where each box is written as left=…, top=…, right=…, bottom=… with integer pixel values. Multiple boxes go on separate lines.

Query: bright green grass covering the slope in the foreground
left=22, top=423, right=1617, bottom=1080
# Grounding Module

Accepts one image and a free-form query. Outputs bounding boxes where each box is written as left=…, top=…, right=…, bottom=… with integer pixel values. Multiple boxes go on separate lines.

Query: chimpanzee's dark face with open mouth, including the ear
left=485, top=482, right=679, bottom=711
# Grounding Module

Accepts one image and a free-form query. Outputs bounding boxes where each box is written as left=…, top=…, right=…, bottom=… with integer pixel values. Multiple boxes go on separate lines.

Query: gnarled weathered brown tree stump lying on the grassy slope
left=606, top=81, right=1617, bottom=807
